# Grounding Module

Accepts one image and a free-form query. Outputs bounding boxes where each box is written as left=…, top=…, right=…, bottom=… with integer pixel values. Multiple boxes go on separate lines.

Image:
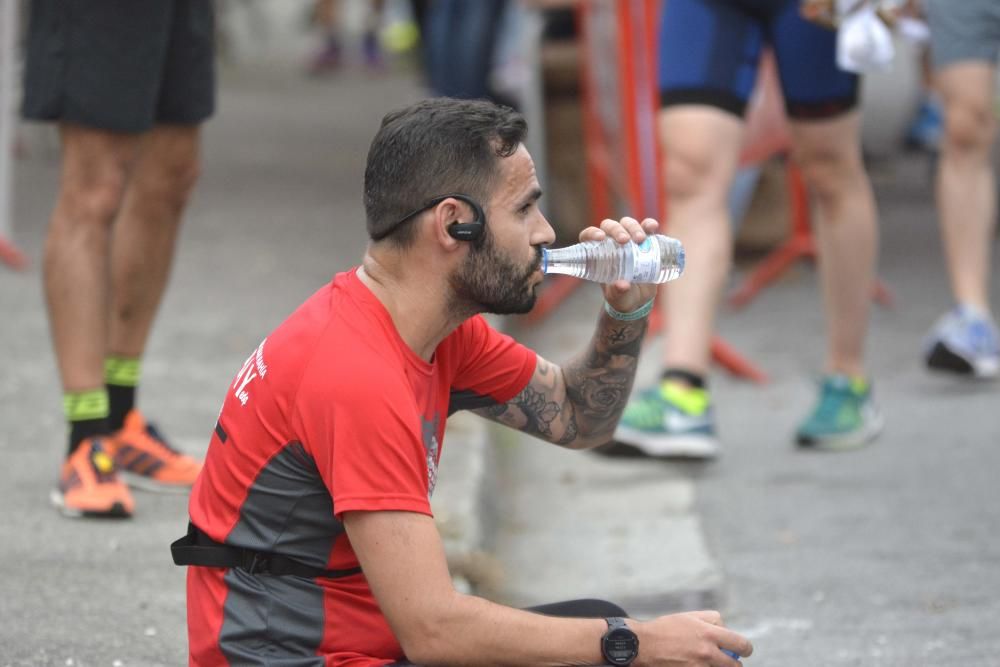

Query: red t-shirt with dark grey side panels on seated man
left=187, top=271, right=536, bottom=667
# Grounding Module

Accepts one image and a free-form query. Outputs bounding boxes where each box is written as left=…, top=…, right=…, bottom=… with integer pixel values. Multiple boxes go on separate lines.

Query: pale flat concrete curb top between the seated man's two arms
left=488, top=426, right=722, bottom=617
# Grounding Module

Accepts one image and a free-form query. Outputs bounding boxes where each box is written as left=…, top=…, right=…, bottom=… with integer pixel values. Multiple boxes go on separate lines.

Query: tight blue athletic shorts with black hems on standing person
left=659, top=0, right=858, bottom=120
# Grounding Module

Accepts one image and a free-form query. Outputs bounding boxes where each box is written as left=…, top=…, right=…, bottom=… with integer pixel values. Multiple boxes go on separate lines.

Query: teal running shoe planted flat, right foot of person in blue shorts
left=796, top=375, right=883, bottom=450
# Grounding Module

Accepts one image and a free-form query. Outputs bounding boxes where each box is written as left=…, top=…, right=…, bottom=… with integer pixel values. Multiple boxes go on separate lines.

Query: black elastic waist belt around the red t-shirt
left=170, top=522, right=361, bottom=579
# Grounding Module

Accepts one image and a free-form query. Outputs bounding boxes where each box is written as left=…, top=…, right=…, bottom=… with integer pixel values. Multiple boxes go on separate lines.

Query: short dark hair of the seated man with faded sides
left=365, top=97, right=528, bottom=247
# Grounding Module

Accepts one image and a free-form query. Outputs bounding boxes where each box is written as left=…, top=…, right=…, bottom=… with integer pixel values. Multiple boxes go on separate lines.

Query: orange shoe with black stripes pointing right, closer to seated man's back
left=109, top=410, right=201, bottom=493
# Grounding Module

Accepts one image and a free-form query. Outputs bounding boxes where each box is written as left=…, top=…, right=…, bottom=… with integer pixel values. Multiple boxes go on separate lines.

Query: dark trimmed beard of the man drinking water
left=451, top=228, right=542, bottom=315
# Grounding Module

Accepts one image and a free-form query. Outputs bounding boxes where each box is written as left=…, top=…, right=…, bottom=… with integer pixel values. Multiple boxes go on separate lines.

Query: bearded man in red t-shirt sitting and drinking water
left=173, top=98, right=752, bottom=667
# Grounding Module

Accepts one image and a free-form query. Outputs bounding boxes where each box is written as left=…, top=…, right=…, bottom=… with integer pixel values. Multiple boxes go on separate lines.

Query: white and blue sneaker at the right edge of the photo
left=924, top=305, right=1000, bottom=379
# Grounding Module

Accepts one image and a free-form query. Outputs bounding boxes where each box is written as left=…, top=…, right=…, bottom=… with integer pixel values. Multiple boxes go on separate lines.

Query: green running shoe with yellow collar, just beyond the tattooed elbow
left=605, top=380, right=719, bottom=459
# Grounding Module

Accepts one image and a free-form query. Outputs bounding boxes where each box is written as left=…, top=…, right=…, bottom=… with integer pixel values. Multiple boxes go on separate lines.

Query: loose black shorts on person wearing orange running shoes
left=22, top=0, right=215, bottom=133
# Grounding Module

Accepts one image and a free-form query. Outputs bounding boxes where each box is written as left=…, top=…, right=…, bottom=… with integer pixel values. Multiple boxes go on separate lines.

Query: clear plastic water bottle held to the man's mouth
left=542, top=234, right=684, bottom=283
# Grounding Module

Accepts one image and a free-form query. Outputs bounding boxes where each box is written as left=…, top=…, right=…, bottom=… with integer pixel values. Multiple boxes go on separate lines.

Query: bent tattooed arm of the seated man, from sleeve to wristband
left=475, top=312, right=646, bottom=449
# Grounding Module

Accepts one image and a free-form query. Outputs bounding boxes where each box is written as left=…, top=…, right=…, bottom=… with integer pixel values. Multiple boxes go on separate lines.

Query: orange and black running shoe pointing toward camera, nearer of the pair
left=51, top=437, right=135, bottom=519
